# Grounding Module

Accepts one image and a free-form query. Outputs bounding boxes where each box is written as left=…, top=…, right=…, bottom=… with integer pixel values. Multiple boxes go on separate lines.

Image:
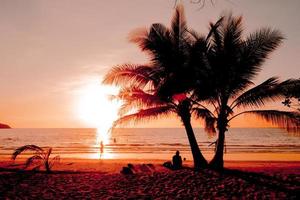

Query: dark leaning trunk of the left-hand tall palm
left=182, top=117, right=208, bottom=170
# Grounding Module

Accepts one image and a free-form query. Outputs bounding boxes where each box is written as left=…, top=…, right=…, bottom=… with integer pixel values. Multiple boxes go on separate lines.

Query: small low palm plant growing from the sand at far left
left=12, top=145, right=59, bottom=173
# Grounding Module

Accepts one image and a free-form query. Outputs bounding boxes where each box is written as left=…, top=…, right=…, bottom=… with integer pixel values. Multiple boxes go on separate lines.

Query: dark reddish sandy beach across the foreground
left=0, top=159, right=300, bottom=199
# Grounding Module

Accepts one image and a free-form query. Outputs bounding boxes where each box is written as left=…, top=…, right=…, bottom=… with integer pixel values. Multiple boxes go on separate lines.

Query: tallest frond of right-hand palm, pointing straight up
left=209, top=13, right=245, bottom=98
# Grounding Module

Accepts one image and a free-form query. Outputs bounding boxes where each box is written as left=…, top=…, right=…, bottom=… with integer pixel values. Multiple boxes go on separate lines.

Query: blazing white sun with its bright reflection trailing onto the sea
left=77, top=79, right=120, bottom=158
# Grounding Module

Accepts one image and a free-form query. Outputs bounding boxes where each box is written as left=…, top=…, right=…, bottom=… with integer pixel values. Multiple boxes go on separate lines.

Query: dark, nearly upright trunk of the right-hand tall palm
left=209, top=129, right=225, bottom=170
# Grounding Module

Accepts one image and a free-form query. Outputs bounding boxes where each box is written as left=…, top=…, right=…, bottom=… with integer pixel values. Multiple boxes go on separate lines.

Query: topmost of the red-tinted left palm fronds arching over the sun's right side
left=103, top=64, right=153, bottom=86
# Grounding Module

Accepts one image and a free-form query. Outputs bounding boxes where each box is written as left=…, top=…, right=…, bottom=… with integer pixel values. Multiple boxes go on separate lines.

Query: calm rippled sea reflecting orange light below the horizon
left=0, top=128, right=300, bottom=160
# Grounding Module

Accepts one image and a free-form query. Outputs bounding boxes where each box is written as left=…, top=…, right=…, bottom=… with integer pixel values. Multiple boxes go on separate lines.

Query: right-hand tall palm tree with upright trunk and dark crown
left=195, top=15, right=300, bottom=169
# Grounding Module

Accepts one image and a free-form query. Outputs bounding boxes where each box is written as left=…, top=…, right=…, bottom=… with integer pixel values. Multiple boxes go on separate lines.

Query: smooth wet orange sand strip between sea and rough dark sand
left=0, top=157, right=300, bottom=174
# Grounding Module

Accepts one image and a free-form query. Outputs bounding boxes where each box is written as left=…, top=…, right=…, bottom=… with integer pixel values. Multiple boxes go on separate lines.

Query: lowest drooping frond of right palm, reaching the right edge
left=244, top=110, right=300, bottom=133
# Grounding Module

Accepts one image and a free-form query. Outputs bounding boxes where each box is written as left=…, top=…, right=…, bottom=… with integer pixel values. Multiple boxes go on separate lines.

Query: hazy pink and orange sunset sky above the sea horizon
left=0, top=0, right=300, bottom=128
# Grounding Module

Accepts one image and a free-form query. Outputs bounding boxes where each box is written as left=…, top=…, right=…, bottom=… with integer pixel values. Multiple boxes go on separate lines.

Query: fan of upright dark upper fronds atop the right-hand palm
left=208, top=14, right=283, bottom=98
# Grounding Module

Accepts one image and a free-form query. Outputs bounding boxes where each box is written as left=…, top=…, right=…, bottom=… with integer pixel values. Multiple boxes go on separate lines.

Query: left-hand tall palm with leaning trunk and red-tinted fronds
left=104, top=5, right=207, bottom=169
